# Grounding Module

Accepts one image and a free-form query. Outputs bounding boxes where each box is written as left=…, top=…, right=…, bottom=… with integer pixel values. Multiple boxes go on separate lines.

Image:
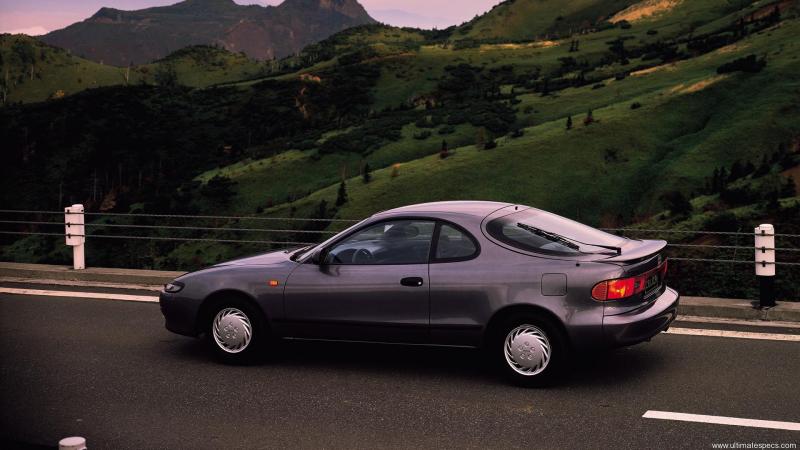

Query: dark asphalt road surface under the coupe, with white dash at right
left=0, top=294, right=800, bottom=449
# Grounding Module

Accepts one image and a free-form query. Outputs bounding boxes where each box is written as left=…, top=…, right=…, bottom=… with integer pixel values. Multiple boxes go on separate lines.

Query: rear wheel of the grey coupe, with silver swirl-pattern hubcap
left=488, top=315, right=569, bottom=387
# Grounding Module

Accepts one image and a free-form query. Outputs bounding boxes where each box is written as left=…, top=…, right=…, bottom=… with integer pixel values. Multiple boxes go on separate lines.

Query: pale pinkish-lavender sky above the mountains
left=0, top=0, right=500, bottom=35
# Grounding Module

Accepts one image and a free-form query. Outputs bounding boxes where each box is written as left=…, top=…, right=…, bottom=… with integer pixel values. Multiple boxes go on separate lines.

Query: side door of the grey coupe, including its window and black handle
left=284, top=219, right=435, bottom=343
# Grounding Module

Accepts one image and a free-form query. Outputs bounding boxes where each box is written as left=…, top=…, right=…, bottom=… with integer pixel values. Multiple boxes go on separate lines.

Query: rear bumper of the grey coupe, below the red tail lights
left=603, top=287, right=680, bottom=347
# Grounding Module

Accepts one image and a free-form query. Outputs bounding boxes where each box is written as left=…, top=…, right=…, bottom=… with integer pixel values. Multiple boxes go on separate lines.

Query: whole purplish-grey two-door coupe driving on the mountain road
left=161, top=201, right=679, bottom=386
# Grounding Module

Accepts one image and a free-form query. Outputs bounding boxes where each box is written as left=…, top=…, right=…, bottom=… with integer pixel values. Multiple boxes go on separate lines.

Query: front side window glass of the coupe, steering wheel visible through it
left=325, top=220, right=435, bottom=265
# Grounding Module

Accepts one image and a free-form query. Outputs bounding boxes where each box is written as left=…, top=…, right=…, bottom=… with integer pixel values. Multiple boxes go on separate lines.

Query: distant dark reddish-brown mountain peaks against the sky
left=41, top=0, right=375, bottom=66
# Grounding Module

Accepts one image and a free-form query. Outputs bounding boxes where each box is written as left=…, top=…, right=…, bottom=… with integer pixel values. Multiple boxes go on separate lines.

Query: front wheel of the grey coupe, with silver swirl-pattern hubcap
left=205, top=297, right=269, bottom=365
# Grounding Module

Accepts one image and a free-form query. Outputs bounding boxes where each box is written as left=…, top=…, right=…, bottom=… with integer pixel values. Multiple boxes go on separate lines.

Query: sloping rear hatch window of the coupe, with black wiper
left=486, top=208, right=626, bottom=255
